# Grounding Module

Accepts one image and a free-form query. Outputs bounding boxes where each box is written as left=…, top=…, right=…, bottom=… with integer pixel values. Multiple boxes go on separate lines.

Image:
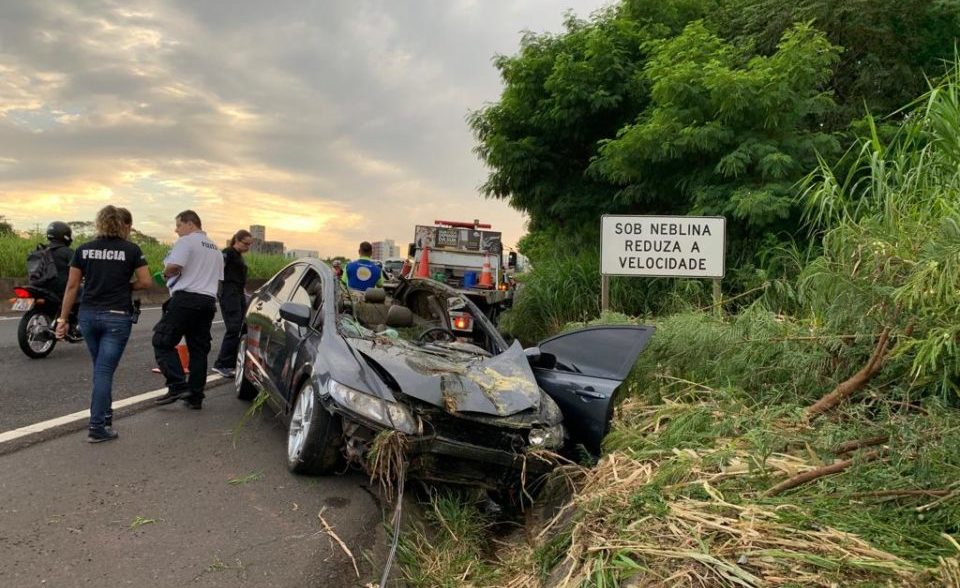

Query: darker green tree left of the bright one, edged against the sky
left=470, top=1, right=708, bottom=231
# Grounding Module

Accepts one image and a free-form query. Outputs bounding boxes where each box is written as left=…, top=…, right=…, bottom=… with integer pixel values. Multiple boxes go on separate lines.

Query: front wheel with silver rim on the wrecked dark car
left=287, top=380, right=343, bottom=474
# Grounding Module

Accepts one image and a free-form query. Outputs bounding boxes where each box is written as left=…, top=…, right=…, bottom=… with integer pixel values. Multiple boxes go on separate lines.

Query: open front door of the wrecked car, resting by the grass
left=530, top=325, right=655, bottom=455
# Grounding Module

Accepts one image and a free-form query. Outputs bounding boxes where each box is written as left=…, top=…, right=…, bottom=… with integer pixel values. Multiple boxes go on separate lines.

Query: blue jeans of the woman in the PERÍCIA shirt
left=79, top=307, right=133, bottom=429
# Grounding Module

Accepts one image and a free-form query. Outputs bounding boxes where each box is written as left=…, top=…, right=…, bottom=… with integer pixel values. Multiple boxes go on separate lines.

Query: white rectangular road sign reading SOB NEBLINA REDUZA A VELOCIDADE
left=600, top=215, right=726, bottom=278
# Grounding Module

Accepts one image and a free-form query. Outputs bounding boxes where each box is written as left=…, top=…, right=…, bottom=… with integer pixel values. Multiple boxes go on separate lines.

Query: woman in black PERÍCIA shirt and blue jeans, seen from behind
left=57, top=206, right=151, bottom=443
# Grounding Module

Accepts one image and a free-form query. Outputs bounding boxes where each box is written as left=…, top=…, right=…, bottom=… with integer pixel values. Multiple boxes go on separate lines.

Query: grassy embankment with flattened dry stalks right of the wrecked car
left=392, top=66, right=960, bottom=587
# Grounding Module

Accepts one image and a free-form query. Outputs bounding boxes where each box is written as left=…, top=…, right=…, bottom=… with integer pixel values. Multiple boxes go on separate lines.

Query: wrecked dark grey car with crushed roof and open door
left=235, top=259, right=653, bottom=489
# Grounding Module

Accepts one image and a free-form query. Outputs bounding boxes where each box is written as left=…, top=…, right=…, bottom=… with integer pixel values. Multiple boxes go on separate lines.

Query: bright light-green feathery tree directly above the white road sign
left=590, top=21, right=839, bottom=252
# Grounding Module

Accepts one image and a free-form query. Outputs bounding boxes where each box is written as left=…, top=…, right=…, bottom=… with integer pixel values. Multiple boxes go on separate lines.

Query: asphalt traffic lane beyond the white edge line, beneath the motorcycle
left=0, top=307, right=223, bottom=433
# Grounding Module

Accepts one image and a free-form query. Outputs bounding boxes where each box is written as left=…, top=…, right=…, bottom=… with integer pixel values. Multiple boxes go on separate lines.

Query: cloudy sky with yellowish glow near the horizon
left=0, top=0, right=609, bottom=257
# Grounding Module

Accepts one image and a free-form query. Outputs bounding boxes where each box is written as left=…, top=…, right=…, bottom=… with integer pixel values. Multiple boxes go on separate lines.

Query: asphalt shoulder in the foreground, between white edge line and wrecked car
left=0, top=386, right=386, bottom=587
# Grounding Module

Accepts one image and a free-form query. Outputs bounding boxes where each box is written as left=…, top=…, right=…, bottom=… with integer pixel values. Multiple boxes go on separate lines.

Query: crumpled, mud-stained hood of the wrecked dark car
left=348, top=338, right=540, bottom=416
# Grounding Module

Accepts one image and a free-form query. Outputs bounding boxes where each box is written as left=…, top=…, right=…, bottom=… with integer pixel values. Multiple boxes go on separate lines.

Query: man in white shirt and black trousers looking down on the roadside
left=153, top=210, right=223, bottom=409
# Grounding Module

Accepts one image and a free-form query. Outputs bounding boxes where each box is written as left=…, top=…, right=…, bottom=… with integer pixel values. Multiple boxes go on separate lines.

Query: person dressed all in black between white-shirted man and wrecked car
left=213, top=229, right=253, bottom=378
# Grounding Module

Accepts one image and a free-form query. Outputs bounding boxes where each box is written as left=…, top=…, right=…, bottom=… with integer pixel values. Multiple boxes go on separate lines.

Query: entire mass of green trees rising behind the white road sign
left=470, top=0, right=960, bottom=264
